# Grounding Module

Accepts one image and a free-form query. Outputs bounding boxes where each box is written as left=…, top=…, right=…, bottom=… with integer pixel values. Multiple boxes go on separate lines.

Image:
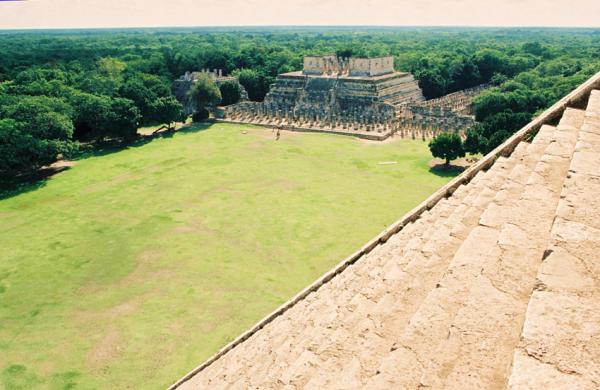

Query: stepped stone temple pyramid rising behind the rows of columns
left=264, top=56, right=424, bottom=120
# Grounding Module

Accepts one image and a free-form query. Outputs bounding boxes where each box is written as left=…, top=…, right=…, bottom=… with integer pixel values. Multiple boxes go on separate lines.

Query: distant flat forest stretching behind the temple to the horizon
left=0, top=28, right=600, bottom=100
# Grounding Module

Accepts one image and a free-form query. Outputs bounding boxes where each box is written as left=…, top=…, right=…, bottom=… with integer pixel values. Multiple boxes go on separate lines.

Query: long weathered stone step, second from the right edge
left=414, top=110, right=583, bottom=388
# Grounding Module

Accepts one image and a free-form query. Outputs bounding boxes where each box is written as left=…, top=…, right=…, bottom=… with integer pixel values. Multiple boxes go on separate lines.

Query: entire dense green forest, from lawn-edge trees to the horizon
left=0, top=27, right=600, bottom=175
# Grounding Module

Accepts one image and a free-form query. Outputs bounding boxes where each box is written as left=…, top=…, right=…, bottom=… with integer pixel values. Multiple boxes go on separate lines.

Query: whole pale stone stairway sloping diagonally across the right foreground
left=172, top=73, right=600, bottom=389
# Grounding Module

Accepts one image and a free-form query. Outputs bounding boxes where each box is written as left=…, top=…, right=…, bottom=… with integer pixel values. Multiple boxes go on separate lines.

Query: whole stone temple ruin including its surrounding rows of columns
left=219, top=55, right=481, bottom=140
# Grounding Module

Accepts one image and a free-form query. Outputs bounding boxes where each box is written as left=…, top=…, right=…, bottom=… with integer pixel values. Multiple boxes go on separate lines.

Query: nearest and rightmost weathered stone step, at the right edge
left=508, top=91, right=600, bottom=390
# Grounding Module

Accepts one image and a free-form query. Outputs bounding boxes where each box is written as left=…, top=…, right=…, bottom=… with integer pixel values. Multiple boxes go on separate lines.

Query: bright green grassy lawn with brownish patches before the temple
left=0, top=124, right=450, bottom=389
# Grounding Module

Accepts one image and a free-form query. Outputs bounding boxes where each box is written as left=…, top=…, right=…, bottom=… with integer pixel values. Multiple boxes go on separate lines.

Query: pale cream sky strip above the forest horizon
left=0, top=0, right=600, bottom=29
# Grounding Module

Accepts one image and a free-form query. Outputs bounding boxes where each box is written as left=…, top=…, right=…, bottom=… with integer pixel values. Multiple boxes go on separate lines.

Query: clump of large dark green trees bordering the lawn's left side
left=0, top=57, right=183, bottom=176
